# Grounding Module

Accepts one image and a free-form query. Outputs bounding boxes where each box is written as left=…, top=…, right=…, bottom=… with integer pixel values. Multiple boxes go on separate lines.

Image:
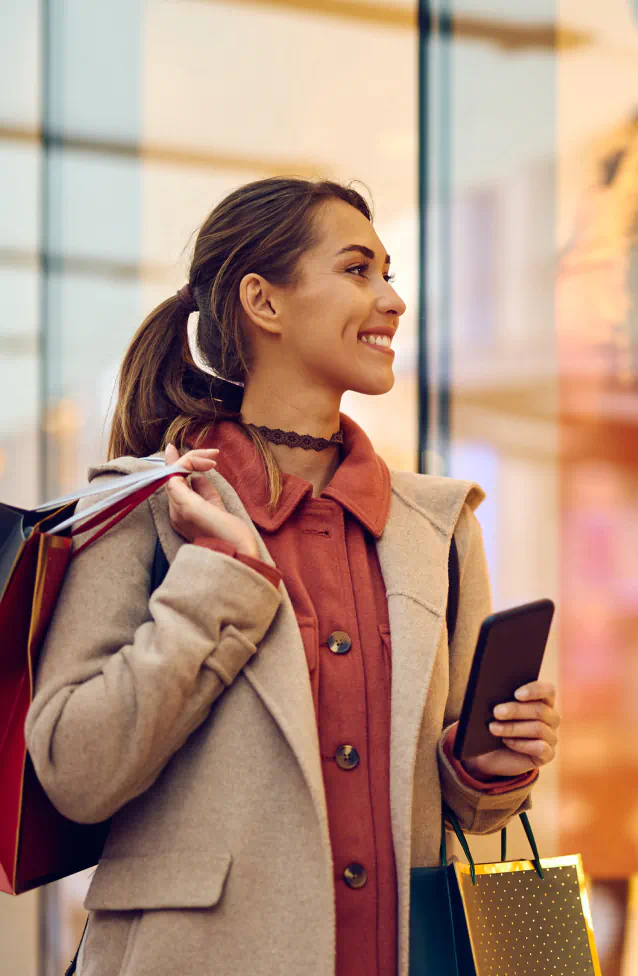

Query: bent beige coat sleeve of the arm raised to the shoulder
left=25, top=476, right=281, bottom=823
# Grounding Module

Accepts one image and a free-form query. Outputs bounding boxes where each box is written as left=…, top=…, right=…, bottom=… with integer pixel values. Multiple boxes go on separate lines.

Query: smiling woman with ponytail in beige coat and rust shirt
left=27, top=179, right=558, bottom=976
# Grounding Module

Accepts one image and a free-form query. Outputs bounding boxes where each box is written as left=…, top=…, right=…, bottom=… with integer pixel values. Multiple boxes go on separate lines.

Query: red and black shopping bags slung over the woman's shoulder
left=0, top=459, right=185, bottom=894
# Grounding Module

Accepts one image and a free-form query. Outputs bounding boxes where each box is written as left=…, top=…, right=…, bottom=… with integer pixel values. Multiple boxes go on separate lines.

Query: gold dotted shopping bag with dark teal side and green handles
left=410, top=808, right=601, bottom=976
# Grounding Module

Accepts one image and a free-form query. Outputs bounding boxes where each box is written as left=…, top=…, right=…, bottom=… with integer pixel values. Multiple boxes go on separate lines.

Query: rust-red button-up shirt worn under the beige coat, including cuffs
left=192, top=414, right=528, bottom=976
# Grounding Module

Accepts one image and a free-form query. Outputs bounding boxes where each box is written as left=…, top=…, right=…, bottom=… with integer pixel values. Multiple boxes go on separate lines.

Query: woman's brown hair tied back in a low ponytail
left=108, top=177, right=372, bottom=513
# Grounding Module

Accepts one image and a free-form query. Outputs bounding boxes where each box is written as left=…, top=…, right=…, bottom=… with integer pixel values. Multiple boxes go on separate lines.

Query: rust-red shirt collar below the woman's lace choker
left=201, top=413, right=391, bottom=539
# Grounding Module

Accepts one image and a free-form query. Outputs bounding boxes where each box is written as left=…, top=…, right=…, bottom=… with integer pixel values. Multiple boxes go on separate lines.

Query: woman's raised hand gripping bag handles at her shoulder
left=165, top=444, right=259, bottom=559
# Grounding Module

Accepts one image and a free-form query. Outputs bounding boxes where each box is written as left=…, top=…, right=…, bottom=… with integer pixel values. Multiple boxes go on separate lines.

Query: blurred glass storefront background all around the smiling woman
left=0, top=0, right=638, bottom=976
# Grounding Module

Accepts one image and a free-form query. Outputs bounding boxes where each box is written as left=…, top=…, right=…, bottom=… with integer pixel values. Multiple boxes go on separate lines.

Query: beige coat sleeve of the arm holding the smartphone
left=438, top=503, right=537, bottom=834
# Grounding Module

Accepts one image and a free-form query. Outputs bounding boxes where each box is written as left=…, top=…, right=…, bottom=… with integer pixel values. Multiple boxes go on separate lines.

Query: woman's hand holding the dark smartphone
left=462, top=681, right=560, bottom=780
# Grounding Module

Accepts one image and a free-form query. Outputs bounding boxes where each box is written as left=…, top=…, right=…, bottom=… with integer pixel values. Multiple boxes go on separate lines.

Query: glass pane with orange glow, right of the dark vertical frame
left=421, top=0, right=638, bottom=976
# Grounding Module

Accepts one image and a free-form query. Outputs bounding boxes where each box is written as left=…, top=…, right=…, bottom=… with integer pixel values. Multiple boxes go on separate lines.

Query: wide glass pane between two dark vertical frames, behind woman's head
left=37, top=0, right=418, bottom=971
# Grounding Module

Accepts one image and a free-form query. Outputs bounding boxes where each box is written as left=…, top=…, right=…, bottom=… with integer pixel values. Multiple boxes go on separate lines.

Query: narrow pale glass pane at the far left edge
left=0, top=0, right=41, bottom=976
